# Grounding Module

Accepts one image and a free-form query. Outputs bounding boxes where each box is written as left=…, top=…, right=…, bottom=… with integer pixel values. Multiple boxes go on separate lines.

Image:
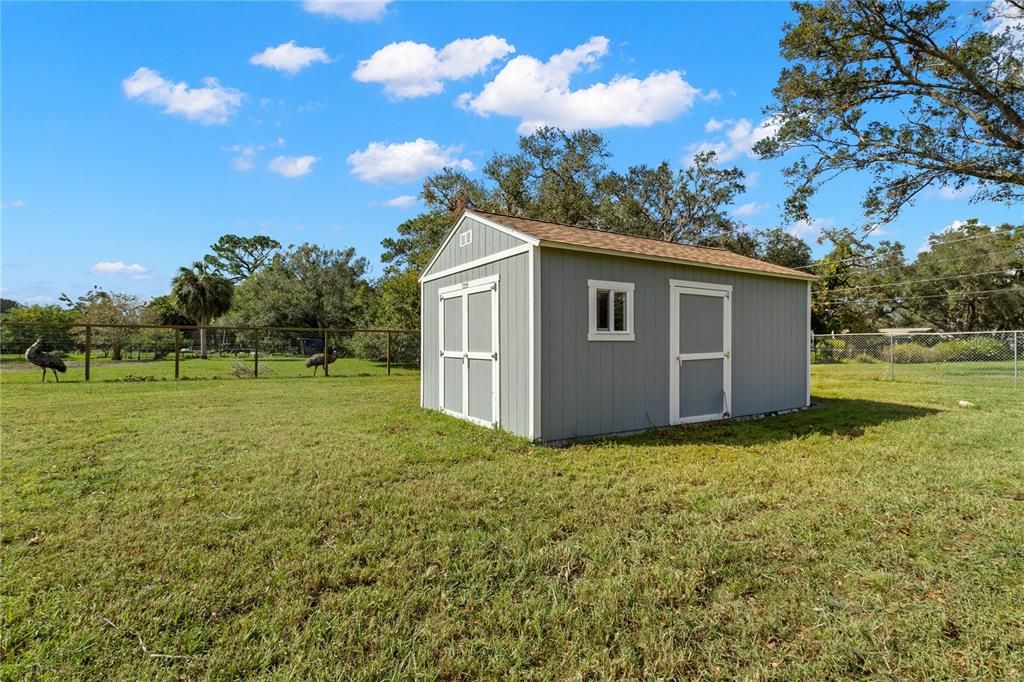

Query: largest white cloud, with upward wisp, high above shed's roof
left=457, top=36, right=700, bottom=134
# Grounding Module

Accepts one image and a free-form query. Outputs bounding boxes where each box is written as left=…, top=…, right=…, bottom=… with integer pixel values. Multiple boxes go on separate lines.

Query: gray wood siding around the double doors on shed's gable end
left=420, top=251, right=529, bottom=436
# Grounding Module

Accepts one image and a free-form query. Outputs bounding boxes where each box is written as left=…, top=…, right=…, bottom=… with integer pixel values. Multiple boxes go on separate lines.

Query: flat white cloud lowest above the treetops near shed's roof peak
left=347, top=137, right=474, bottom=182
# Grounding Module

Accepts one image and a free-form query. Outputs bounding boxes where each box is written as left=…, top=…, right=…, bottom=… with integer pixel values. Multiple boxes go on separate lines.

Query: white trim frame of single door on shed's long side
left=669, top=280, right=732, bottom=425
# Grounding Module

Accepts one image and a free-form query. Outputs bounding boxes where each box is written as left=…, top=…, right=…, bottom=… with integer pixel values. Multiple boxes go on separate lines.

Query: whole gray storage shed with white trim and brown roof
left=420, top=209, right=814, bottom=441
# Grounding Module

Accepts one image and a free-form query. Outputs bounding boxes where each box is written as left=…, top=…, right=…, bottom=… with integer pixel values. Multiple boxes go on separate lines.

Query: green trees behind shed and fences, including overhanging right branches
left=0, top=0, right=1024, bottom=350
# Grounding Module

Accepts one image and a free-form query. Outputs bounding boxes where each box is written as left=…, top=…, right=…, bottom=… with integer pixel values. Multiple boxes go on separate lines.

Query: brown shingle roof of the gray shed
left=466, top=209, right=816, bottom=280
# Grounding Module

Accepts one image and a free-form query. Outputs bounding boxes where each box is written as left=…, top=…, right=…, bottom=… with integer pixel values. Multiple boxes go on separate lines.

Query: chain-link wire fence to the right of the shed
left=811, top=331, right=1024, bottom=388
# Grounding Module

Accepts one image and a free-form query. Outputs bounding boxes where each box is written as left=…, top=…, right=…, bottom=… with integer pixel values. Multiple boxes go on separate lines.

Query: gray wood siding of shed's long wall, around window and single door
left=541, top=248, right=807, bottom=440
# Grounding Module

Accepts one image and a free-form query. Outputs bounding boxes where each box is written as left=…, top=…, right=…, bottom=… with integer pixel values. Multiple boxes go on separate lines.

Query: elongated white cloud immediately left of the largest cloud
left=352, top=36, right=515, bottom=99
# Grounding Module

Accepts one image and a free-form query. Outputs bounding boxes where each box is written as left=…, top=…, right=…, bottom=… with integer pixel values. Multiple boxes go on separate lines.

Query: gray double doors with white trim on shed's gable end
left=438, top=276, right=501, bottom=427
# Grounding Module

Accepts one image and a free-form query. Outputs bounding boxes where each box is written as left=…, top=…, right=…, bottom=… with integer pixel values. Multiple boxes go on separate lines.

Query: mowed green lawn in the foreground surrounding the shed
left=0, top=368, right=1024, bottom=680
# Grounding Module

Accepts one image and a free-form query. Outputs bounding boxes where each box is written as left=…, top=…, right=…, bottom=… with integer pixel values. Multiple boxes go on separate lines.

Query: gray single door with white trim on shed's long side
left=669, top=280, right=732, bottom=424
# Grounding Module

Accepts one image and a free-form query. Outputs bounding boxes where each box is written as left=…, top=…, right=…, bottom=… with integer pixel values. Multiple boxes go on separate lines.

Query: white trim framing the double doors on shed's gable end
left=437, top=274, right=501, bottom=428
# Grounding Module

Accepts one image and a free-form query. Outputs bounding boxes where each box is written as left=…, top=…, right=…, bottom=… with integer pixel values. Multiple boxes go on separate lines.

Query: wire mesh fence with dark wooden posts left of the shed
left=0, top=323, right=420, bottom=381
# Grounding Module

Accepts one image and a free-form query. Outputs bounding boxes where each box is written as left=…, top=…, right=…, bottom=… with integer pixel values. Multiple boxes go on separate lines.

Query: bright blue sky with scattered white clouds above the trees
left=0, top=0, right=1024, bottom=303
